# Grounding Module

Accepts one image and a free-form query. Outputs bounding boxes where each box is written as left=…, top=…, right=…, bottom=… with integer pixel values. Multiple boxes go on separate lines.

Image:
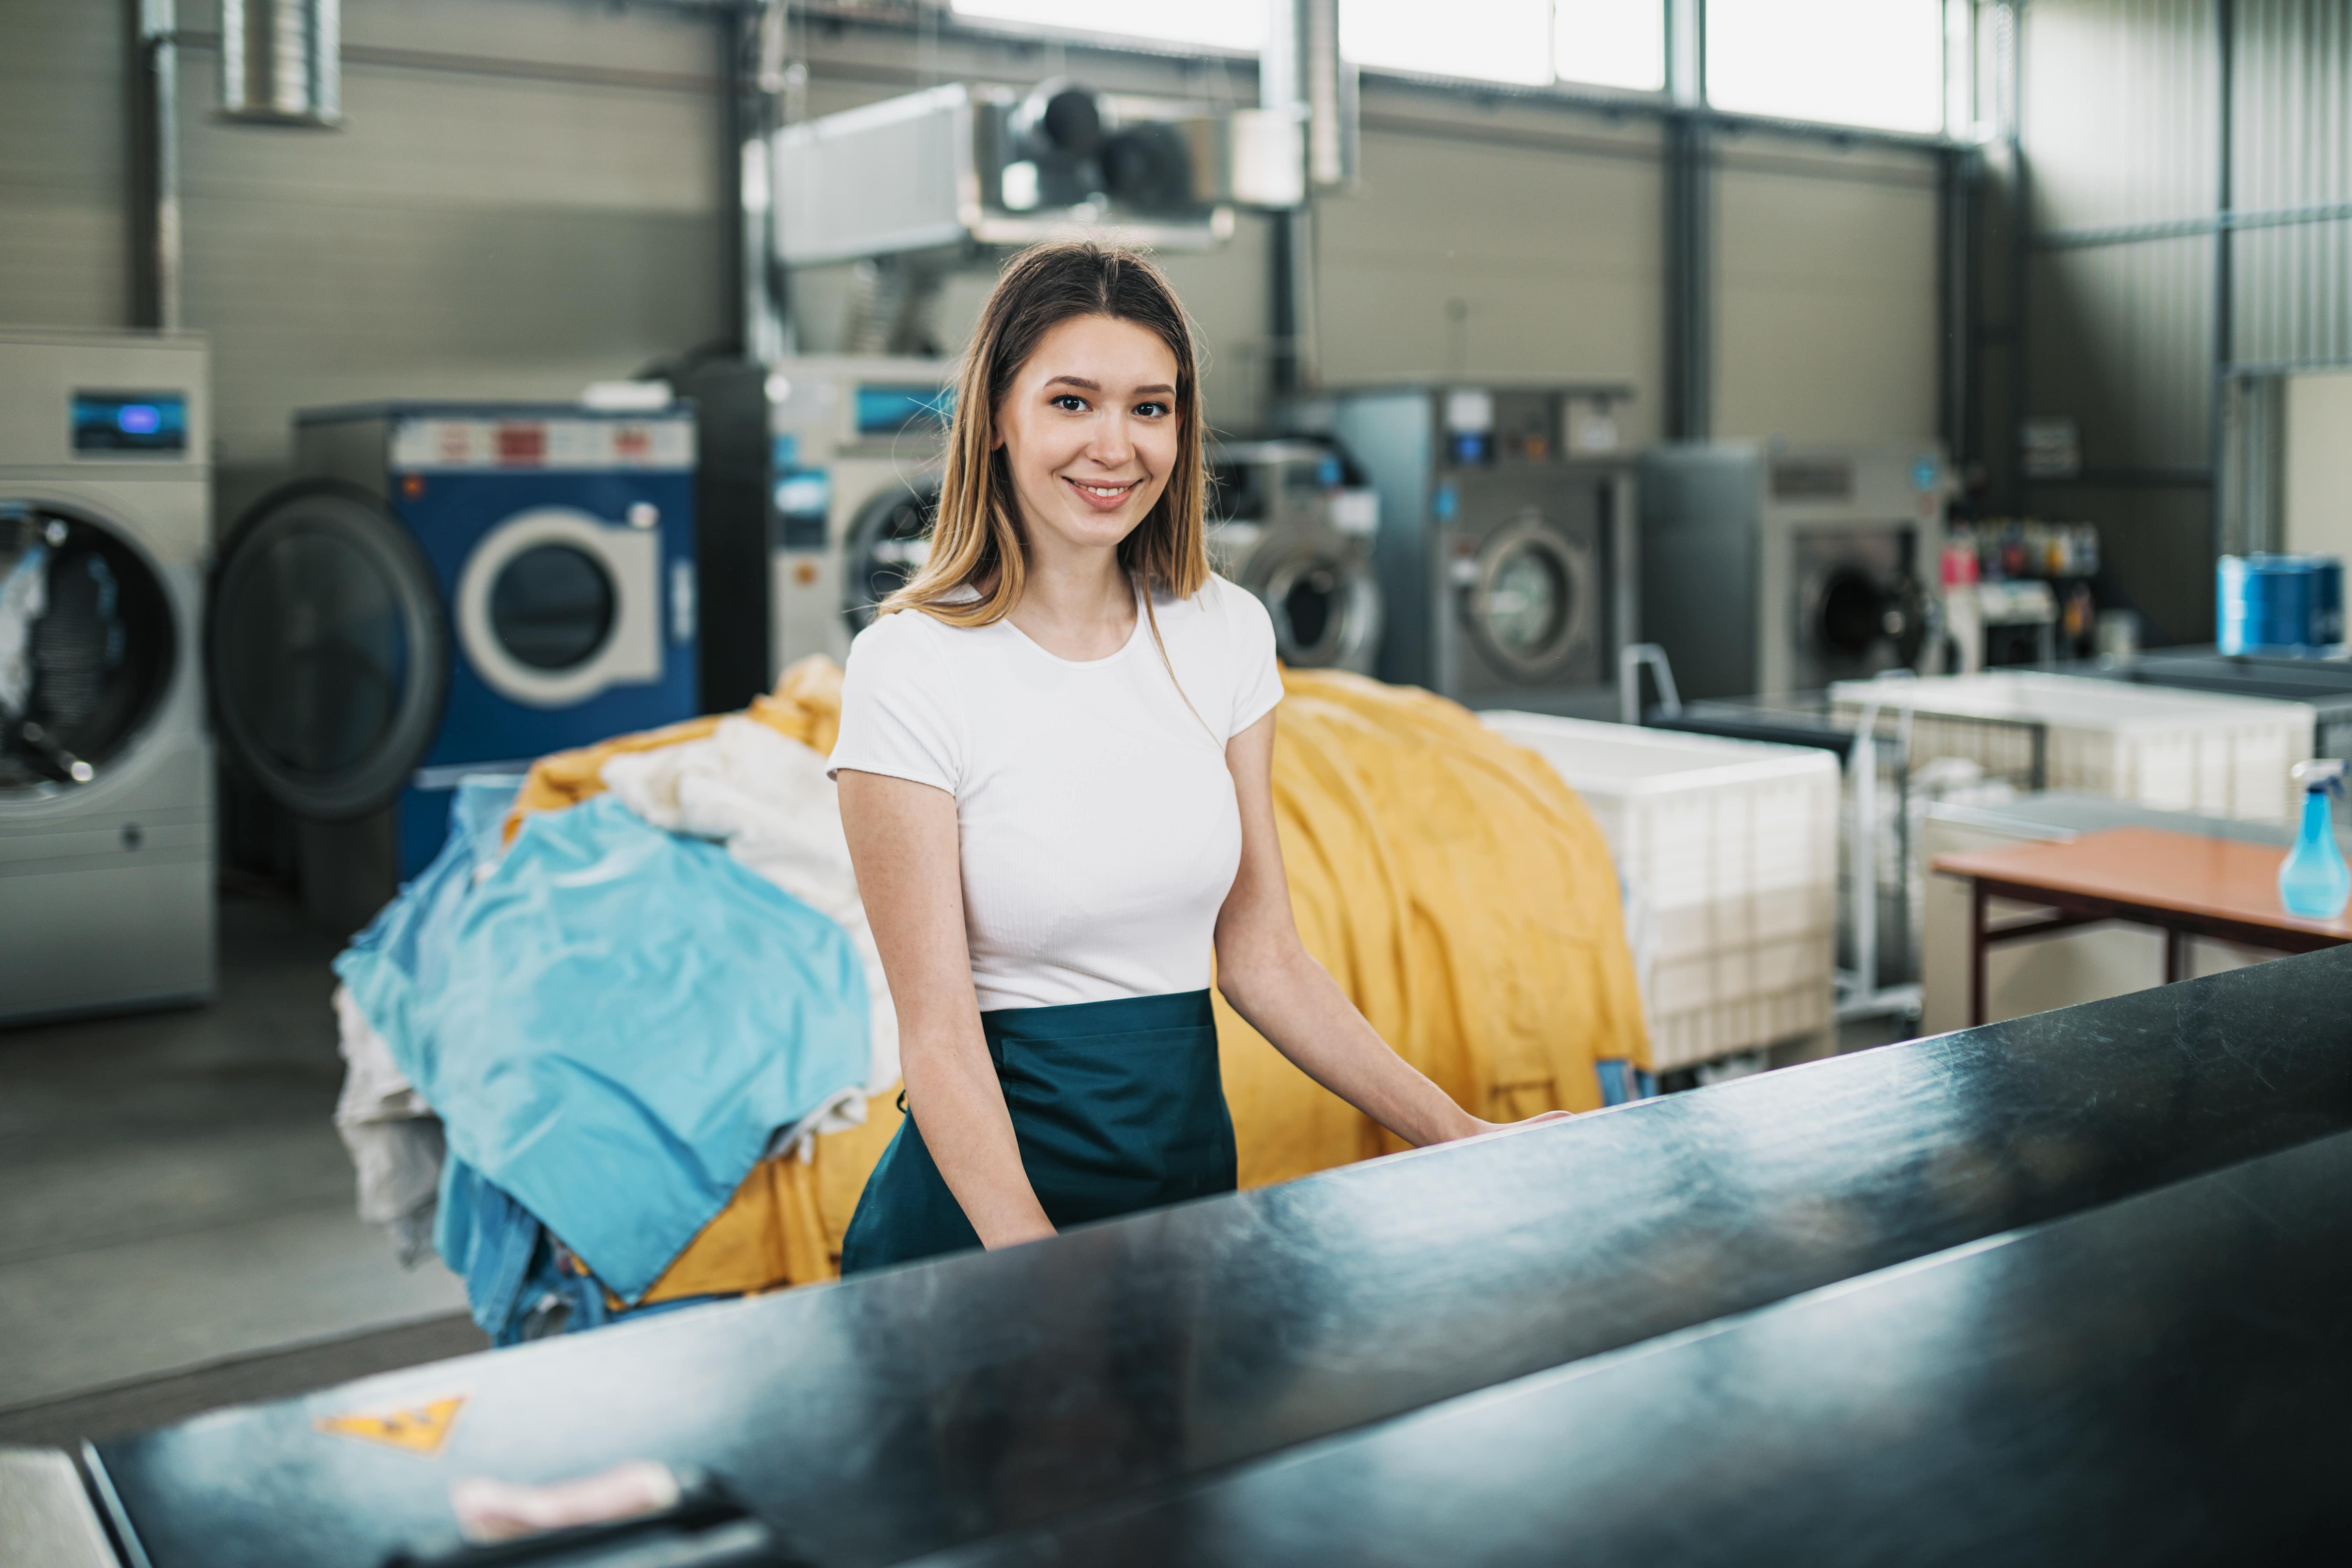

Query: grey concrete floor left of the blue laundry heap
left=0, top=896, right=482, bottom=1441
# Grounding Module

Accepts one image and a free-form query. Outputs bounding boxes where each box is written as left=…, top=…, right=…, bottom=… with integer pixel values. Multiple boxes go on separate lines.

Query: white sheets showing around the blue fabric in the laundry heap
left=334, top=717, right=898, bottom=1265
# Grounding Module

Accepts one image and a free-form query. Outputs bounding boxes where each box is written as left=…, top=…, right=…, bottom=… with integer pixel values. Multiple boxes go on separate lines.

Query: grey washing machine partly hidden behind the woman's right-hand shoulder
left=1206, top=440, right=1383, bottom=675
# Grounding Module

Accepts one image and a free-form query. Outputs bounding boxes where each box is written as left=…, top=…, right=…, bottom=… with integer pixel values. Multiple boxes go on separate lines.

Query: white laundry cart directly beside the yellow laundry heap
left=1479, top=712, right=1839, bottom=1072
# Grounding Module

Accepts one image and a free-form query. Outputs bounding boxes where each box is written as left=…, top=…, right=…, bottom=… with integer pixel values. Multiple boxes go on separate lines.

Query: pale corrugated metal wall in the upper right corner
left=2023, top=0, right=2352, bottom=642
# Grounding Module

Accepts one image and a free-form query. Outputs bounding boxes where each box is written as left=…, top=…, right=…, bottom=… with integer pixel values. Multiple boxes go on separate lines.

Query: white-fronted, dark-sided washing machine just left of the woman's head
left=670, top=355, right=955, bottom=712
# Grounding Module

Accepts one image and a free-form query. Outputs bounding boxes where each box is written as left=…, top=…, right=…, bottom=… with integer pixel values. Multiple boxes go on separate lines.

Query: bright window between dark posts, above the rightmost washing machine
left=1708, top=0, right=1943, bottom=134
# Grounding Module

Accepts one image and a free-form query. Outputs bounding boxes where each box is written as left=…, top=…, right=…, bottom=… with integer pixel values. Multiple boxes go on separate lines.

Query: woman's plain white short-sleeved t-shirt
left=828, top=576, right=1282, bottom=1013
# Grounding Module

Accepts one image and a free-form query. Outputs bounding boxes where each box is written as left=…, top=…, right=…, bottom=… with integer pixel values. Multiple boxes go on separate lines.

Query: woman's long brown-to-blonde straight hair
left=875, top=240, right=1209, bottom=621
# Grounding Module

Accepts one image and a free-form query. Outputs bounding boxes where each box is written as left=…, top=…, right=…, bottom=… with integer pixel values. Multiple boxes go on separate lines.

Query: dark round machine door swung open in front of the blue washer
left=205, top=482, right=449, bottom=820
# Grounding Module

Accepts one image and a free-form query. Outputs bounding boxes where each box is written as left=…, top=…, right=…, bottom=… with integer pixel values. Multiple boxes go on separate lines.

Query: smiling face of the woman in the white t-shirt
left=997, top=315, right=1181, bottom=564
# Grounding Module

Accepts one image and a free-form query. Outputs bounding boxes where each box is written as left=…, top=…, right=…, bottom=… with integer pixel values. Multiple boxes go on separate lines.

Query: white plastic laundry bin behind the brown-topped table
left=1830, top=670, right=2317, bottom=823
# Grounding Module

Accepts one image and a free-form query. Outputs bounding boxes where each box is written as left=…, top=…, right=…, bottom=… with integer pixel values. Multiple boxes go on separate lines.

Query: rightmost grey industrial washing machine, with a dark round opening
left=1639, top=442, right=1952, bottom=698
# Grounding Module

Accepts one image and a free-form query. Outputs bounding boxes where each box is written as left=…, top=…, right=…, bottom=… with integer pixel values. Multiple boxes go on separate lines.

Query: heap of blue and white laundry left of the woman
left=336, top=668, right=898, bottom=1342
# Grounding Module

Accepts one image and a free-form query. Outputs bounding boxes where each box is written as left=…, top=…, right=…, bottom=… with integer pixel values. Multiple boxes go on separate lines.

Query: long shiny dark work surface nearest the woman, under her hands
left=83, top=950, right=2352, bottom=1568
